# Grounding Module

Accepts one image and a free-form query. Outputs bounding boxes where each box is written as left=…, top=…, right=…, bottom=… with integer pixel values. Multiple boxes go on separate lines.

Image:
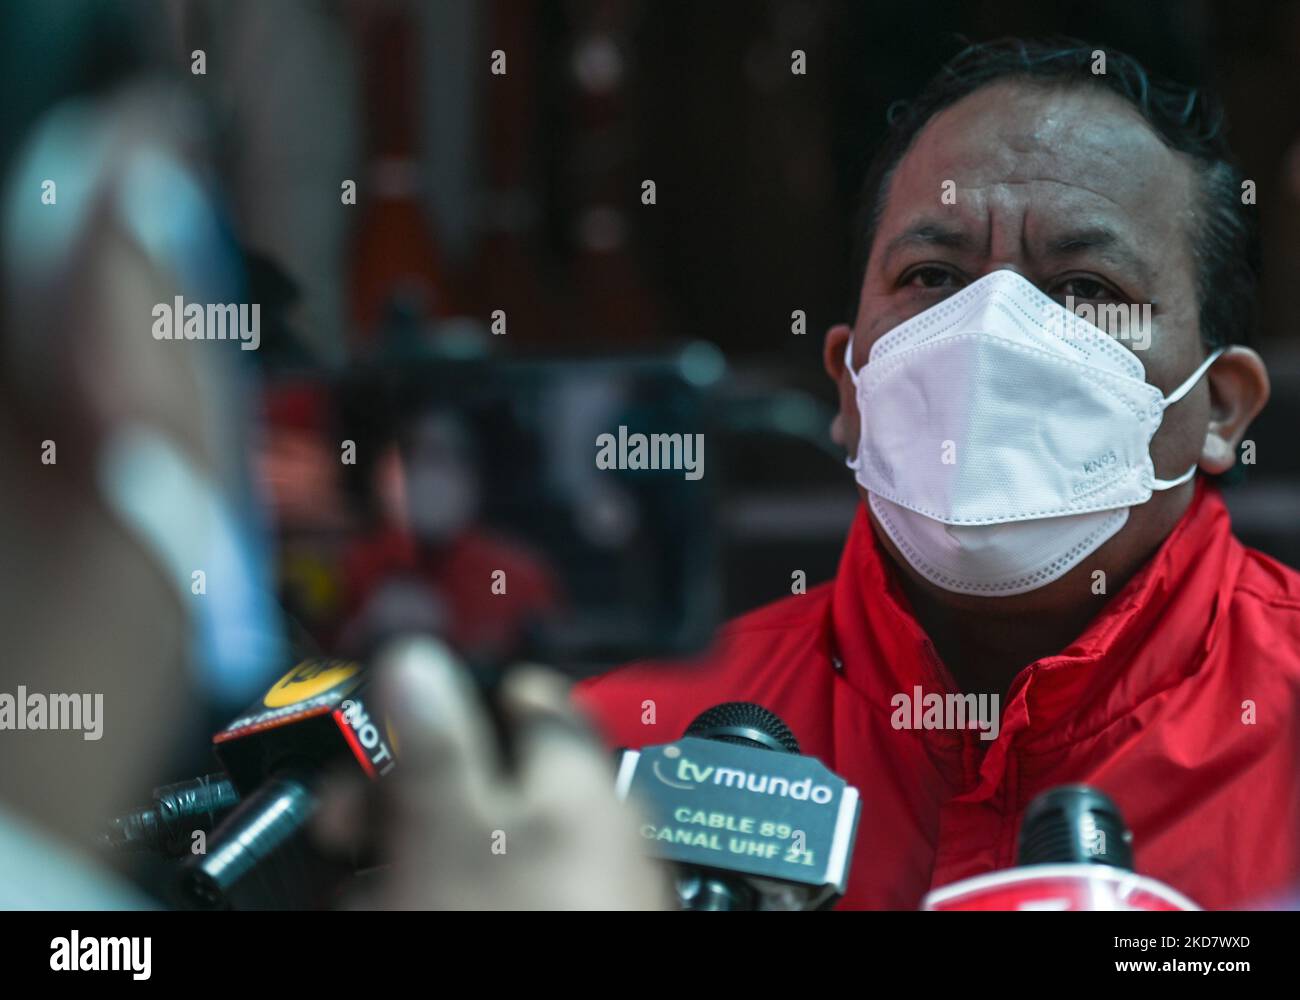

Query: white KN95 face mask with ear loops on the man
left=845, top=270, right=1223, bottom=597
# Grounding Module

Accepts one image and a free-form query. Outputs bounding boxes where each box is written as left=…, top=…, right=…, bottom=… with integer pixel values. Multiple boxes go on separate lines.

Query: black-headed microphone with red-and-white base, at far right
left=920, top=784, right=1200, bottom=910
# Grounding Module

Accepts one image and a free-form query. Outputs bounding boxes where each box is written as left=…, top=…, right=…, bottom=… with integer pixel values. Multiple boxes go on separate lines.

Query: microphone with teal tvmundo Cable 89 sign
left=618, top=702, right=861, bottom=910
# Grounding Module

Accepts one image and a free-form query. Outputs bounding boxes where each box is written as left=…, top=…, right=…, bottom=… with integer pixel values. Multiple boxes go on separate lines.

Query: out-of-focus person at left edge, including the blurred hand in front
left=0, top=3, right=666, bottom=909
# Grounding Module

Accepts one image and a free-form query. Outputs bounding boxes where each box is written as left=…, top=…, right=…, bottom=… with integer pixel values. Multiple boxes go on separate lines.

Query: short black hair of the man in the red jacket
left=850, top=38, right=1260, bottom=347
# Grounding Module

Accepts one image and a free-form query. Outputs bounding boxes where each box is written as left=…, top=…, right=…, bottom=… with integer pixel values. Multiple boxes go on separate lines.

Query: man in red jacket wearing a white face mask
left=577, top=42, right=1300, bottom=909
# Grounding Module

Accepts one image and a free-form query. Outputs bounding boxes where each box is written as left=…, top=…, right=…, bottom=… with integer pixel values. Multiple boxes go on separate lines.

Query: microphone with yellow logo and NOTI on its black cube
left=179, top=658, right=395, bottom=909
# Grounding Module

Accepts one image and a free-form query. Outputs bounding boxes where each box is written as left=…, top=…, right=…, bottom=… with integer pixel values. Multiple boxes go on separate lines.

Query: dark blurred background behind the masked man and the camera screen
left=33, top=0, right=1300, bottom=631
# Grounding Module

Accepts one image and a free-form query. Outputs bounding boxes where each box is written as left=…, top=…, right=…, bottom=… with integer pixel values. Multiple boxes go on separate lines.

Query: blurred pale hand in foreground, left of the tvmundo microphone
left=317, top=638, right=671, bottom=910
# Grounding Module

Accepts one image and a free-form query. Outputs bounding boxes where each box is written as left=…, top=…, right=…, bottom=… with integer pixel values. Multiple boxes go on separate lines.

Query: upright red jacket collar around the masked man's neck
left=831, top=481, right=1243, bottom=766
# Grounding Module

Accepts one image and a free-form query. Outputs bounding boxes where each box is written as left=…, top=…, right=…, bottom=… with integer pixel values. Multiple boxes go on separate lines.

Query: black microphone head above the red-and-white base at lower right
left=1015, top=784, right=1134, bottom=871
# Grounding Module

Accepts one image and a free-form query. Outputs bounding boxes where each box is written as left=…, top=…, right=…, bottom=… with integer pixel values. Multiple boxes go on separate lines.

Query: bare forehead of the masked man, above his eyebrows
left=881, top=81, right=1192, bottom=233
